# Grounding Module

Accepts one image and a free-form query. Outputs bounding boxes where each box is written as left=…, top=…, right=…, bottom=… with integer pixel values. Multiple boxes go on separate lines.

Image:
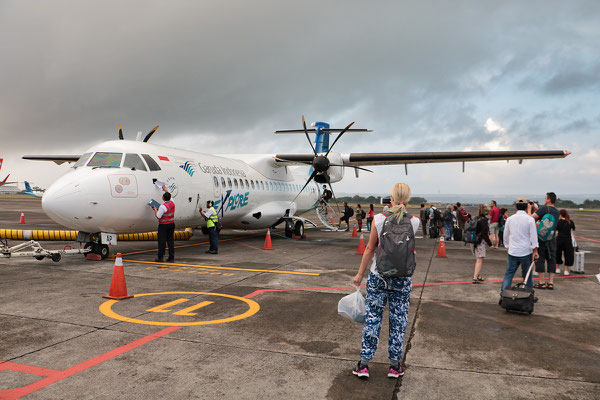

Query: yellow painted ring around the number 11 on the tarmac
left=98, top=292, right=260, bottom=326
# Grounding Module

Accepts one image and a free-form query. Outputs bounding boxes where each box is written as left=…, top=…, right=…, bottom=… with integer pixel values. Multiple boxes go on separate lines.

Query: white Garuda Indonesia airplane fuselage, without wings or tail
left=42, top=140, right=319, bottom=233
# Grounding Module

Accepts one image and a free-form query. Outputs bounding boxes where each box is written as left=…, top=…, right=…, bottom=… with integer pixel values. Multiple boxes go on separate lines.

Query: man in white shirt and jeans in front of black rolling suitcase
left=501, top=197, right=539, bottom=290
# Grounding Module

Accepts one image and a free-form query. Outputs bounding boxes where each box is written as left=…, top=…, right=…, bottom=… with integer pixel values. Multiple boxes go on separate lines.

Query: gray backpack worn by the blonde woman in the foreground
left=375, top=212, right=416, bottom=278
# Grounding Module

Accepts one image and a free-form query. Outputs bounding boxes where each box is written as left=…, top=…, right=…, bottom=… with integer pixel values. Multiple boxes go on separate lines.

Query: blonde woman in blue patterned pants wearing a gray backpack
left=352, top=183, right=420, bottom=378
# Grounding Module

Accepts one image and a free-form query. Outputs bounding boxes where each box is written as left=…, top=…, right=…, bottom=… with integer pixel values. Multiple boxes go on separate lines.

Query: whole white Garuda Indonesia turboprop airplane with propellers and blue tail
left=23, top=117, right=570, bottom=256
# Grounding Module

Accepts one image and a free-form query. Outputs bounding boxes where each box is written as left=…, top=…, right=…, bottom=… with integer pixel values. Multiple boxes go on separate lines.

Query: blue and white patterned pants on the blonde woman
left=360, top=273, right=412, bottom=361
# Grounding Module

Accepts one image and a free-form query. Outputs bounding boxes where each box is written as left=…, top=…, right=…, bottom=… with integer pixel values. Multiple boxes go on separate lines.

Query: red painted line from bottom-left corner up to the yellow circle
left=0, top=326, right=181, bottom=400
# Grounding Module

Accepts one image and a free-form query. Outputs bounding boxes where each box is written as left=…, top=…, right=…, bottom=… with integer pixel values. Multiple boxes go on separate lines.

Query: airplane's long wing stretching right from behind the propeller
left=274, top=150, right=571, bottom=167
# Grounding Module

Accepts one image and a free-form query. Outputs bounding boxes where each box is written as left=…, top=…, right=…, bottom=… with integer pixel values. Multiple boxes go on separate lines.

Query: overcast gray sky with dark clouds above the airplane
left=0, top=0, right=600, bottom=197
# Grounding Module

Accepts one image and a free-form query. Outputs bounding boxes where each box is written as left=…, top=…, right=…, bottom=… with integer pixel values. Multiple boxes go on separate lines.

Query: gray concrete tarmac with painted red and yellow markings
left=0, top=197, right=600, bottom=400
